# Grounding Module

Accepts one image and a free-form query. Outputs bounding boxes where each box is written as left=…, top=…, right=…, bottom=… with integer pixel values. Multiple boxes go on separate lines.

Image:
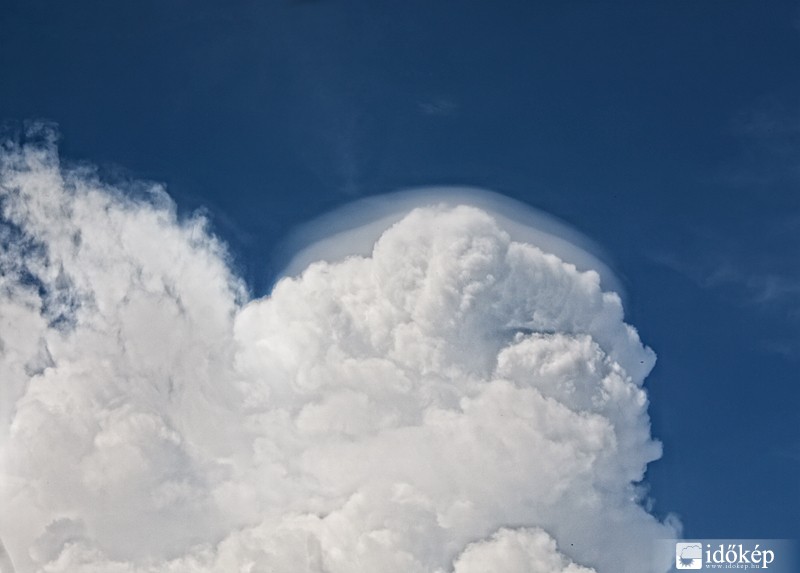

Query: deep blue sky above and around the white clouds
left=0, top=0, right=800, bottom=538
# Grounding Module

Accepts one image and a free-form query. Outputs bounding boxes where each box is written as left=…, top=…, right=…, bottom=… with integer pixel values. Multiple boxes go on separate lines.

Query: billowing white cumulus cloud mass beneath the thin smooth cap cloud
left=0, top=135, right=675, bottom=573
